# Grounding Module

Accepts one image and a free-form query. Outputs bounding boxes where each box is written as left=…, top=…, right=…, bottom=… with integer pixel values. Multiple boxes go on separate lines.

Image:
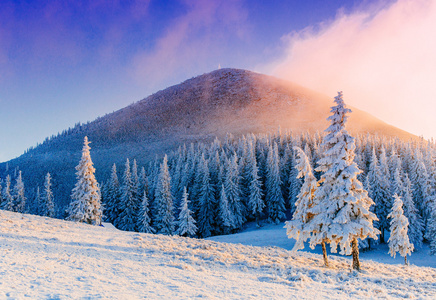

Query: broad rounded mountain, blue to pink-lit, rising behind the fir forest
left=0, top=69, right=414, bottom=209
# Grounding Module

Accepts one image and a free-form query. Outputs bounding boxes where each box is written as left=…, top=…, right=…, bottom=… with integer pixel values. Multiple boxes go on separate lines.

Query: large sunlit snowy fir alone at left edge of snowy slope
left=67, top=136, right=102, bottom=225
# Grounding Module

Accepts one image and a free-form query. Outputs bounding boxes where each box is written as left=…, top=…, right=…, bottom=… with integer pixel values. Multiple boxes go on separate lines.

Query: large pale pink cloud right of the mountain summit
left=268, top=0, right=436, bottom=137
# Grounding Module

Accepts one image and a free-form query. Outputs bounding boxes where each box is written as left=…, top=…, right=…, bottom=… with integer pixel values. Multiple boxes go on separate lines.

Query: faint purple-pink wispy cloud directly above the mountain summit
left=131, top=0, right=247, bottom=86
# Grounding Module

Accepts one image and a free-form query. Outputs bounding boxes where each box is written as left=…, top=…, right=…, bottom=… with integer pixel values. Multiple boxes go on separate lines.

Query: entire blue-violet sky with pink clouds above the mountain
left=0, top=0, right=436, bottom=162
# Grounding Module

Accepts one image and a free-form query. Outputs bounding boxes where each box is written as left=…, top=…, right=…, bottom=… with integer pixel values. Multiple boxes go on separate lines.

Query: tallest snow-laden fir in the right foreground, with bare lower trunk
left=309, top=92, right=379, bottom=270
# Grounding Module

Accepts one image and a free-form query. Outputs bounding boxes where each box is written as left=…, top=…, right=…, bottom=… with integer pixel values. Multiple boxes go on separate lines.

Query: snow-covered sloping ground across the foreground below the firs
left=0, top=210, right=436, bottom=299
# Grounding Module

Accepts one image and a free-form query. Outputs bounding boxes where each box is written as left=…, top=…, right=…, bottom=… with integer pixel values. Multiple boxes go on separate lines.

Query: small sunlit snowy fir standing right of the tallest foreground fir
left=388, top=194, right=413, bottom=265
